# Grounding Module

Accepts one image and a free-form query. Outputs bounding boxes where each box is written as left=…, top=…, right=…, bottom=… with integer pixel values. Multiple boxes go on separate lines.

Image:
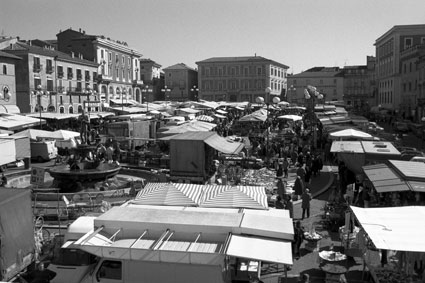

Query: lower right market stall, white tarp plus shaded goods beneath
left=350, top=206, right=425, bottom=283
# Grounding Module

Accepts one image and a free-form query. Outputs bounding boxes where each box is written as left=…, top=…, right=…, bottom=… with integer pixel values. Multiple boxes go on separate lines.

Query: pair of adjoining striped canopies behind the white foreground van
left=131, top=183, right=268, bottom=209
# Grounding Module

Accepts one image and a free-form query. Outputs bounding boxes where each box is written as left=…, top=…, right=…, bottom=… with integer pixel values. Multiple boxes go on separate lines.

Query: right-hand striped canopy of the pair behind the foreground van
left=200, top=185, right=268, bottom=209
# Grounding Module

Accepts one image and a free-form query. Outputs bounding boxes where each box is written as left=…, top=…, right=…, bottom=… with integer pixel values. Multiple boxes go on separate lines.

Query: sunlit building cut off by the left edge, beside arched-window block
left=0, top=51, right=21, bottom=113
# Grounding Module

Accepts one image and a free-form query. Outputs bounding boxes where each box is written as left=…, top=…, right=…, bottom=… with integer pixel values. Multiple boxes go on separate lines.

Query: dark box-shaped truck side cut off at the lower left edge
left=0, top=188, right=36, bottom=281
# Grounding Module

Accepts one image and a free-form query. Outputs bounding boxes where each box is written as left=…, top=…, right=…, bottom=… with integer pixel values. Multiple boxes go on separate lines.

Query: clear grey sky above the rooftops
left=0, top=0, right=425, bottom=74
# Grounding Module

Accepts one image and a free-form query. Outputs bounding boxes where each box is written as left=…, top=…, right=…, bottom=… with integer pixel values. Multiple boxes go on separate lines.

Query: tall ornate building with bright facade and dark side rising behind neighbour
left=56, top=29, right=144, bottom=103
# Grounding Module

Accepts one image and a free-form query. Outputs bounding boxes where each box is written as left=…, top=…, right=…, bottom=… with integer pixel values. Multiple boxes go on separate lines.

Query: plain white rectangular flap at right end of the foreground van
left=226, top=235, right=293, bottom=265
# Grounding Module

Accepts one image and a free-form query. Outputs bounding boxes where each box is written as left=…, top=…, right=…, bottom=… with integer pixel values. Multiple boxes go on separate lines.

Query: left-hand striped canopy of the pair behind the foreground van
left=133, top=183, right=202, bottom=206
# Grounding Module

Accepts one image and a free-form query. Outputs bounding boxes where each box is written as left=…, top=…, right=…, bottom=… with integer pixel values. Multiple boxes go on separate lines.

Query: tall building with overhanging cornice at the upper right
left=375, top=25, right=425, bottom=117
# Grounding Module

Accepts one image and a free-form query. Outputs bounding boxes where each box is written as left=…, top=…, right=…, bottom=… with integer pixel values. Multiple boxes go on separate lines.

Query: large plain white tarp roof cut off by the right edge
left=351, top=206, right=425, bottom=252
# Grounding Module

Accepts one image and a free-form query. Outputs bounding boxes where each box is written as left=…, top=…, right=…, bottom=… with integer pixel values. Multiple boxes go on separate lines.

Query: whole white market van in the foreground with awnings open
left=48, top=204, right=293, bottom=283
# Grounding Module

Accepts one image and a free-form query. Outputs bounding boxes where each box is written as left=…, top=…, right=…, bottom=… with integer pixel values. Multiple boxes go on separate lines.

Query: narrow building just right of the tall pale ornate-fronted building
left=136, top=59, right=164, bottom=101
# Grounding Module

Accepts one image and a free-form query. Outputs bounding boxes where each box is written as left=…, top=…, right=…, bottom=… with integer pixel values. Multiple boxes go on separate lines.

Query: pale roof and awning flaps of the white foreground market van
left=73, top=204, right=293, bottom=265
